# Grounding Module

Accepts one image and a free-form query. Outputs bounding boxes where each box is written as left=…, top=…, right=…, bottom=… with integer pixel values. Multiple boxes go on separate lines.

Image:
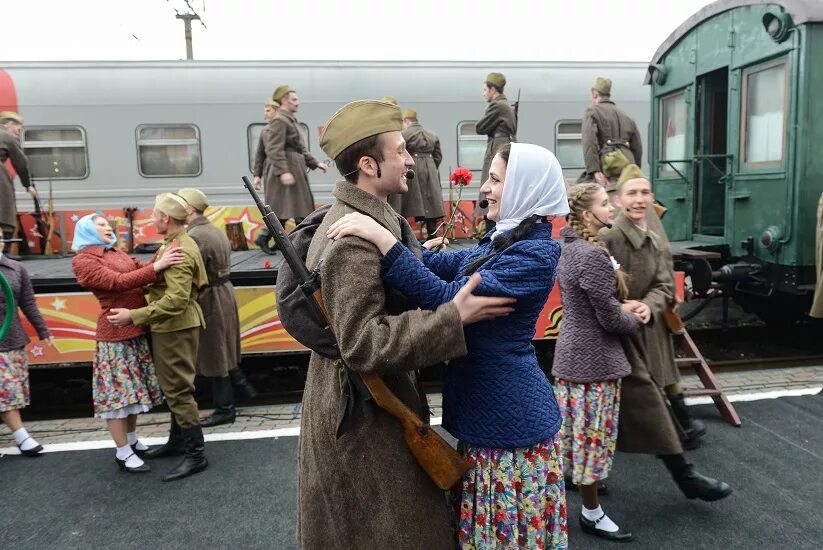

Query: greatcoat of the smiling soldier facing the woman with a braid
left=600, top=215, right=683, bottom=454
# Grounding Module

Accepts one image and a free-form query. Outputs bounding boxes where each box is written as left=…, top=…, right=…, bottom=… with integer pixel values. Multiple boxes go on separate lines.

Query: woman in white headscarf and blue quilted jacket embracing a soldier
left=328, top=143, right=569, bottom=548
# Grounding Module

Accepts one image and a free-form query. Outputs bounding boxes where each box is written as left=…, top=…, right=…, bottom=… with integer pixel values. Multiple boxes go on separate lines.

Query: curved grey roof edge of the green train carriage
left=643, top=0, right=823, bottom=84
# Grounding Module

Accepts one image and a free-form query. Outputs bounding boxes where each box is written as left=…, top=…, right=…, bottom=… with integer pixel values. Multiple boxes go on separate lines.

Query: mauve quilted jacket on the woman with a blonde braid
left=552, top=227, right=638, bottom=383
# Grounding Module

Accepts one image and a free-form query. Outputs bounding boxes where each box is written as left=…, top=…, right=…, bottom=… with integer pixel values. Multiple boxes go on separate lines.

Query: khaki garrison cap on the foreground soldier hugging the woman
left=320, top=99, right=403, bottom=159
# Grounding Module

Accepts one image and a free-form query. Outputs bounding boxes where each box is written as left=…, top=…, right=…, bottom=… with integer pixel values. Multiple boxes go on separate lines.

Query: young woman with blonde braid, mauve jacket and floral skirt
left=552, top=183, right=650, bottom=541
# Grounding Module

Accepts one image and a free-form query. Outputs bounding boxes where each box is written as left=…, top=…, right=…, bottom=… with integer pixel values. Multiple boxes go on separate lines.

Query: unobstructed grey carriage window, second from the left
left=137, top=124, right=202, bottom=178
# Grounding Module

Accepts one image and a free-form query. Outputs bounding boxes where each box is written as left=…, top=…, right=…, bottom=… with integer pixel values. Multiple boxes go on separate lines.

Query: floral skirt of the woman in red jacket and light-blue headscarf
left=92, top=336, right=163, bottom=419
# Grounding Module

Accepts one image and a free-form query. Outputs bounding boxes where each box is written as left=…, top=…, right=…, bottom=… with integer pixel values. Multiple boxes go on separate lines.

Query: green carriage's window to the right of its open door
left=740, top=59, right=789, bottom=167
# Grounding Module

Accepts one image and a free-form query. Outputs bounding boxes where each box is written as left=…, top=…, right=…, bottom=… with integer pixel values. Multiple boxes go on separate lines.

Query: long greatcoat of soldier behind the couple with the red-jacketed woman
left=187, top=216, right=240, bottom=378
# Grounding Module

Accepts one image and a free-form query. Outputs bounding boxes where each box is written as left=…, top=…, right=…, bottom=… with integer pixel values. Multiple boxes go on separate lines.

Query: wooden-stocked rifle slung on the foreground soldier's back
left=243, top=176, right=469, bottom=491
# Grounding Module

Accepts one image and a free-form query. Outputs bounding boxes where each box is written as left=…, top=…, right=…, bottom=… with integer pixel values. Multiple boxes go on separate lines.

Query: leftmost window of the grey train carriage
left=23, top=126, right=89, bottom=180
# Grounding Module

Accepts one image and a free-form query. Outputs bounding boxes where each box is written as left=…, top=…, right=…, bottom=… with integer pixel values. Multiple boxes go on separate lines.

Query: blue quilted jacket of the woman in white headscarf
left=382, top=223, right=561, bottom=448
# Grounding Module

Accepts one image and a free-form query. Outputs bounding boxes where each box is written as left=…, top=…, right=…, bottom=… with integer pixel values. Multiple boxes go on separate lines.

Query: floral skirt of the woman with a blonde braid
left=554, top=378, right=620, bottom=485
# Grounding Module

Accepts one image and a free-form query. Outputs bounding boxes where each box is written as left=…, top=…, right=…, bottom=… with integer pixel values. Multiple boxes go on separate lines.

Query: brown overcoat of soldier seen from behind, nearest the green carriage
left=578, top=99, right=643, bottom=181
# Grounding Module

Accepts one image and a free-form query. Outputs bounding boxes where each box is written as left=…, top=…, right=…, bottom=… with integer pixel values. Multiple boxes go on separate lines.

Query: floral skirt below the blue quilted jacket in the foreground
left=451, top=435, right=568, bottom=549
